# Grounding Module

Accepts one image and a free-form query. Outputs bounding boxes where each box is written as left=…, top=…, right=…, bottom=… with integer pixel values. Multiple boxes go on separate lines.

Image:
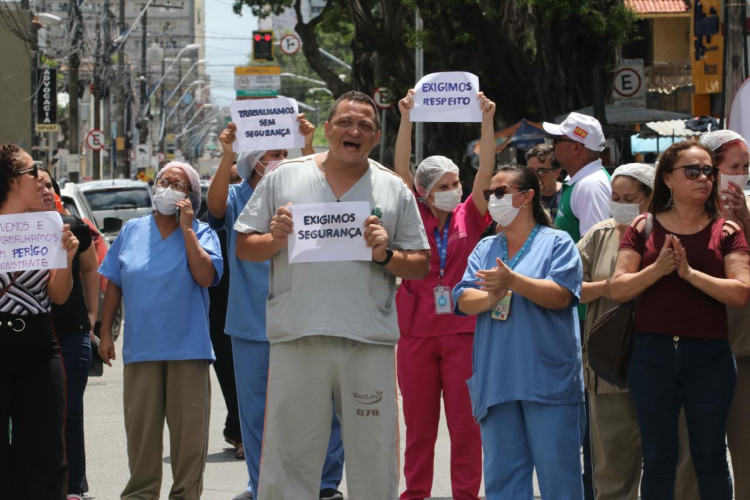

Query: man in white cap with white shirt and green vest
left=544, top=112, right=612, bottom=241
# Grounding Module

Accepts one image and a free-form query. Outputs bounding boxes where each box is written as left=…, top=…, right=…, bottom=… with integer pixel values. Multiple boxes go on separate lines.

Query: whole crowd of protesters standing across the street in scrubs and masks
left=0, top=91, right=750, bottom=500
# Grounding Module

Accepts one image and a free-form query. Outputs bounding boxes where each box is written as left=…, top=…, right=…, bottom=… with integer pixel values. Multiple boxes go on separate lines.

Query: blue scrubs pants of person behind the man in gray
left=232, top=337, right=344, bottom=492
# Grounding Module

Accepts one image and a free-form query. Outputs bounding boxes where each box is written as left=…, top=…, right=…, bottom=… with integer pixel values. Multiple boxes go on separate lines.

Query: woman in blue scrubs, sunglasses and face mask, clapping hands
left=453, top=165, right=584, bottom=500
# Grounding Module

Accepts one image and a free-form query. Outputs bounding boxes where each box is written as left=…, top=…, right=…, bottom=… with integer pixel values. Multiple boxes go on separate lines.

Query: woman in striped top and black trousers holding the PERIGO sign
left=0, top=144, right=78, bottom=500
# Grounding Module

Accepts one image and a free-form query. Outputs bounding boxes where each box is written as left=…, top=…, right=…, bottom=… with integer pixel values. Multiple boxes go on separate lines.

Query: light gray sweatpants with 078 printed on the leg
left=258, top=336, right=399, bottom=500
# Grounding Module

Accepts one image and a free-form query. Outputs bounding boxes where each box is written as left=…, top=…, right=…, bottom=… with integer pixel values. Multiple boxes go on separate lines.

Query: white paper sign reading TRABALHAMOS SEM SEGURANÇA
left=231, top=97, right=305, bottom=152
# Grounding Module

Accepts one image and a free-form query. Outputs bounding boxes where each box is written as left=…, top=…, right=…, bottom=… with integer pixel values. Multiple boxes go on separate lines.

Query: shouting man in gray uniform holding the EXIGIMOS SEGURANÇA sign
left=234, top=91, right=430, bottom=500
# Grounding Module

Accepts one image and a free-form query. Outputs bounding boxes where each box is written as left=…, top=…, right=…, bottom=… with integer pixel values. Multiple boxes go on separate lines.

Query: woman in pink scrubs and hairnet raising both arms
left=394, top=90, right=495, bottom=500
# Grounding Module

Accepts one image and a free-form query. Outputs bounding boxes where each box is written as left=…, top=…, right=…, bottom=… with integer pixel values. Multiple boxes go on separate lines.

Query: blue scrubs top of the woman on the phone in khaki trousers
left=99, top=215, right=223, bottom=364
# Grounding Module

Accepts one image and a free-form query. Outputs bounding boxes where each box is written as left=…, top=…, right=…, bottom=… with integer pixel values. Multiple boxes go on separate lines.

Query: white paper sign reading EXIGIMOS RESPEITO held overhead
left=409, top=71, right=482, bottom=122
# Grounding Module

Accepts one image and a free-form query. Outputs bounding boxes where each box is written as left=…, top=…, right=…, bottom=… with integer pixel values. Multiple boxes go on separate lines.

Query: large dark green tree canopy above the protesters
left=234, top=0, right=635, bottom=166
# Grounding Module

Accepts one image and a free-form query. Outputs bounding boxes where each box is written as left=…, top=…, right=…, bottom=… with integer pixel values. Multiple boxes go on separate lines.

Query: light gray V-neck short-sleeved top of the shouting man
left=234, top=156, right=430, bottom=345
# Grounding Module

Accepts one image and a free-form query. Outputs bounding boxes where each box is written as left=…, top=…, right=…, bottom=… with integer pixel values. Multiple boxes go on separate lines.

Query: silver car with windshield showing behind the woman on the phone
left=78, top=179, right=153, bottom=242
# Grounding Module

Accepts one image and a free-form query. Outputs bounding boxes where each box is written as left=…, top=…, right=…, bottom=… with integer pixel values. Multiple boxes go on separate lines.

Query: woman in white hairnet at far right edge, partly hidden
left=700, top=130, right=750, bottom=498
